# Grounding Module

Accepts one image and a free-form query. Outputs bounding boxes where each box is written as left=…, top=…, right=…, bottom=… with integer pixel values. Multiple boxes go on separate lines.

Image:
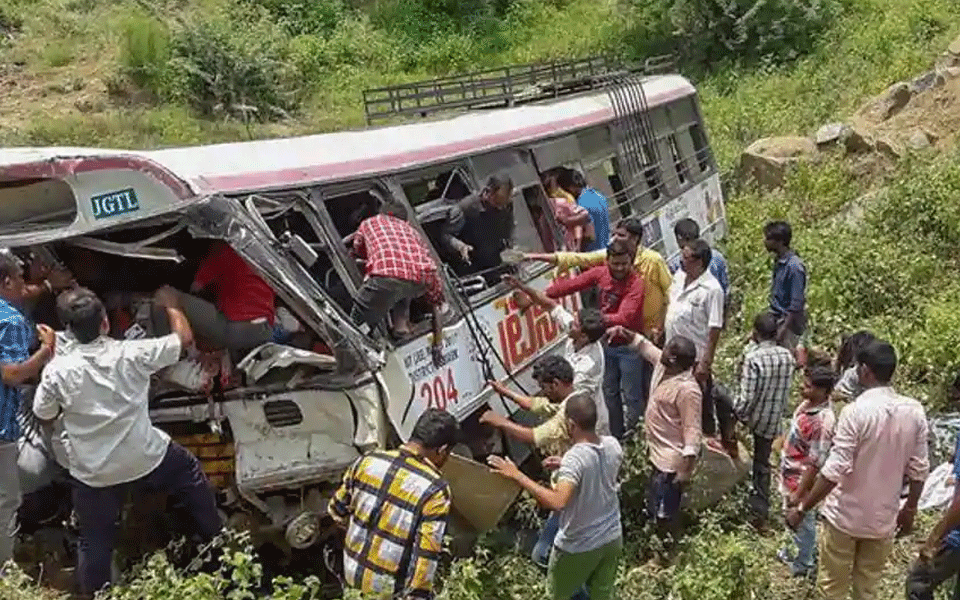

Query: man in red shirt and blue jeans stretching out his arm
left=546, top=240, right=645, bottom=439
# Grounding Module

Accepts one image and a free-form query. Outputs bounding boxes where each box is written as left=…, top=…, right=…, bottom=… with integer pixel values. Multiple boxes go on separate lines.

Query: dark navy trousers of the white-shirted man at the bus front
left=73, top=441, right=223, bottom=595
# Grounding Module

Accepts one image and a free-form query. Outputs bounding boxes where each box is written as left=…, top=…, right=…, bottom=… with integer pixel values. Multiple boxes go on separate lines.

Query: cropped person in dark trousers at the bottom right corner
left=907, top=428, right=960, bottom=600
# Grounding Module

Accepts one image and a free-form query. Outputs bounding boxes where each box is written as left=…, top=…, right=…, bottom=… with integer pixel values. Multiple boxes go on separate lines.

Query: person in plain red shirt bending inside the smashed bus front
left=155, top=240, right=276, bottom=358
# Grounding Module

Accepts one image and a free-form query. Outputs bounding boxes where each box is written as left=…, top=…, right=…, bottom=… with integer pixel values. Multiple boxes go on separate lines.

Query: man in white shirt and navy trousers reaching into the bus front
left=33, top=288, right=222, bottom=596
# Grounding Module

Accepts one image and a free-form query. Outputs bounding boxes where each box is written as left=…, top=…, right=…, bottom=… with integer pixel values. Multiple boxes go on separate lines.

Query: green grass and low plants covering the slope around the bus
left=0, top=0, right=960, bottom=600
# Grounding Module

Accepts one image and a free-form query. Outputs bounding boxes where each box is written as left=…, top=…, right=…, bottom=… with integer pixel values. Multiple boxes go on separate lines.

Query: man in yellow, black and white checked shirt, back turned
left=328, top=409, right=460, bottom=599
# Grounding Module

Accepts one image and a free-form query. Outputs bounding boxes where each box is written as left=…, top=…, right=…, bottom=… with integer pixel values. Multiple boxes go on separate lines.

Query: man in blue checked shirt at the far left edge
left=0, top=251, right=55, bottom=565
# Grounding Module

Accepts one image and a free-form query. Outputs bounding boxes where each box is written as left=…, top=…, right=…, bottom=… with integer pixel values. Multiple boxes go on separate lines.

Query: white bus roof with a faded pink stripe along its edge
left=0, top=75, right=695, bottom=200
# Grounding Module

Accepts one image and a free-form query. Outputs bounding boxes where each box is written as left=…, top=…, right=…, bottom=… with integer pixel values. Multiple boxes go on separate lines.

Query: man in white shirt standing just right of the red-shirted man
left=665, top=240, right=724, bottom=450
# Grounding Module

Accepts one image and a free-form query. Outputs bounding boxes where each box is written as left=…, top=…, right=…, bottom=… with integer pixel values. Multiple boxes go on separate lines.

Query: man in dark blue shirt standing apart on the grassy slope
left=763, top=221, right=807, bottom=350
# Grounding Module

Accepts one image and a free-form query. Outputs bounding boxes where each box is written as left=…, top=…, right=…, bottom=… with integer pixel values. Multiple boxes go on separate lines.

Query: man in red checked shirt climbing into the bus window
left=350, top=202, right=443, bottom=364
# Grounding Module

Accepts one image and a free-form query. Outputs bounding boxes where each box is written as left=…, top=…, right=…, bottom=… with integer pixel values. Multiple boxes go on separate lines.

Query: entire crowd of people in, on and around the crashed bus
left=0, top=163, right=960, bottom=600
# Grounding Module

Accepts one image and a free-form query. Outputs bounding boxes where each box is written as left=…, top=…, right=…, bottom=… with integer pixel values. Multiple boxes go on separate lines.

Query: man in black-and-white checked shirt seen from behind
left=717, top=313, right=796, bottom=528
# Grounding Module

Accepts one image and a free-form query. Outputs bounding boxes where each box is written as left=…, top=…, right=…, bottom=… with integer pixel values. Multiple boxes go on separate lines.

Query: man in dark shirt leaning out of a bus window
left=417, top=176, right=513, bottom=285
